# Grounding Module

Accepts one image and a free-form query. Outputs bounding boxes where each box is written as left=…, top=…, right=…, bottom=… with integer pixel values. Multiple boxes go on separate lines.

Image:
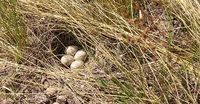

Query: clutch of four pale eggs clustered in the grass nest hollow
left=60, top=45, right=87, bottom=69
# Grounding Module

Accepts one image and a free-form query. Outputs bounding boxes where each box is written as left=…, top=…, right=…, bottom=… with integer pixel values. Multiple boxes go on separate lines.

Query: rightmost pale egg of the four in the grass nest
left=74, top=50, right=87, bottom=61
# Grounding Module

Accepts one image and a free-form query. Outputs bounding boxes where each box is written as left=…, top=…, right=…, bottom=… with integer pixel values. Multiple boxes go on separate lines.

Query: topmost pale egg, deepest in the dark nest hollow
left=65, top=45, right=78, bottom=55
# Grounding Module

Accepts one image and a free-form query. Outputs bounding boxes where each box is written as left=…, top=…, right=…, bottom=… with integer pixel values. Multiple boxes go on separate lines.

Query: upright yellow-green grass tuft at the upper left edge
left=0, top=0, right=26, bottom=62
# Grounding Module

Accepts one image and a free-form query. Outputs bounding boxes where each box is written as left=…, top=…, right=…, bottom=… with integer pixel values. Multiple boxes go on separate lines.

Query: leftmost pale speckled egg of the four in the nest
left=60, top=55, right=74, bottom=66
